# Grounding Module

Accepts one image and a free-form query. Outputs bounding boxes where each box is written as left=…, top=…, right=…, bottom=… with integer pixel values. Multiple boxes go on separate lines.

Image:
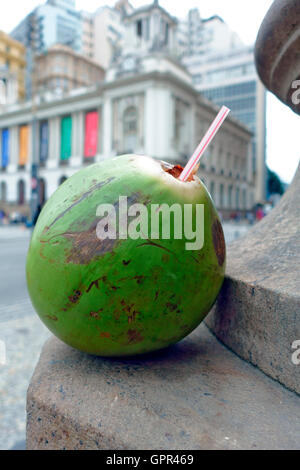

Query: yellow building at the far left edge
left=0, top=31, right=26, bottom=105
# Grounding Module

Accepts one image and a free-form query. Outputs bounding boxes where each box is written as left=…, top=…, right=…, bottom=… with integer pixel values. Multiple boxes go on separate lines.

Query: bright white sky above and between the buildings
left=0, top=0, right=300, bottom=183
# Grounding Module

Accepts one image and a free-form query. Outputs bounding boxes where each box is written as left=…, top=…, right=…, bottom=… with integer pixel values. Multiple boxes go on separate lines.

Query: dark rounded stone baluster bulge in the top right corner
left=255, top=0, right=300, bottom=114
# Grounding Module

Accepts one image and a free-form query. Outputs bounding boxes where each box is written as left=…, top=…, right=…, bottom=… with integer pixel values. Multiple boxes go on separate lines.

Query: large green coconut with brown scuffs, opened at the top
left=26, top=155, right=225, bottom=356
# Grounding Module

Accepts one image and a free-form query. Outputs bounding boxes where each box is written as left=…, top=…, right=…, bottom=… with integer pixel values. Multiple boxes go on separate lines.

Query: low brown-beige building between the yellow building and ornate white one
left=33, top=44, right=104, bottom=95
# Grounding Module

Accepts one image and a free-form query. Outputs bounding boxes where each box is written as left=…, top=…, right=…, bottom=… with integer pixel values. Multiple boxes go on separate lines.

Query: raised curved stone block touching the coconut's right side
left=206, top=163, right=300, bottom=393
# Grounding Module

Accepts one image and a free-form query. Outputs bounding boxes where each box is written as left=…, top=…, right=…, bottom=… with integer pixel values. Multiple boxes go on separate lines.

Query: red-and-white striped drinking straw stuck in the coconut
left=179, top=106, right=230, bottom=181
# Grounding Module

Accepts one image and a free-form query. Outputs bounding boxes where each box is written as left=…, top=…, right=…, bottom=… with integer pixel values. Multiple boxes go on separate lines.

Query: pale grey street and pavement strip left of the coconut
left=0, top=227, right=49, bottom=450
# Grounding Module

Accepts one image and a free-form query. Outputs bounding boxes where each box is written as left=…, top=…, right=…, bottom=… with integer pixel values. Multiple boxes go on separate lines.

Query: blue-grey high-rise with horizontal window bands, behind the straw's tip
left=184, top=46, right=267, bottom=202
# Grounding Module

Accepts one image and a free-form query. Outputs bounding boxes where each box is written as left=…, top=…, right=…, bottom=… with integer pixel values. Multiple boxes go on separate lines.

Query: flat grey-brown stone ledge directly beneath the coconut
left=27, top=325, right=300, bottom=450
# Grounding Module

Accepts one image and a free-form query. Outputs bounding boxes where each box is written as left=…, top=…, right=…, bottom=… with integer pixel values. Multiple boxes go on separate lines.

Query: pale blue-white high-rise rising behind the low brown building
left=11, top=0, right=82, bottom=97
